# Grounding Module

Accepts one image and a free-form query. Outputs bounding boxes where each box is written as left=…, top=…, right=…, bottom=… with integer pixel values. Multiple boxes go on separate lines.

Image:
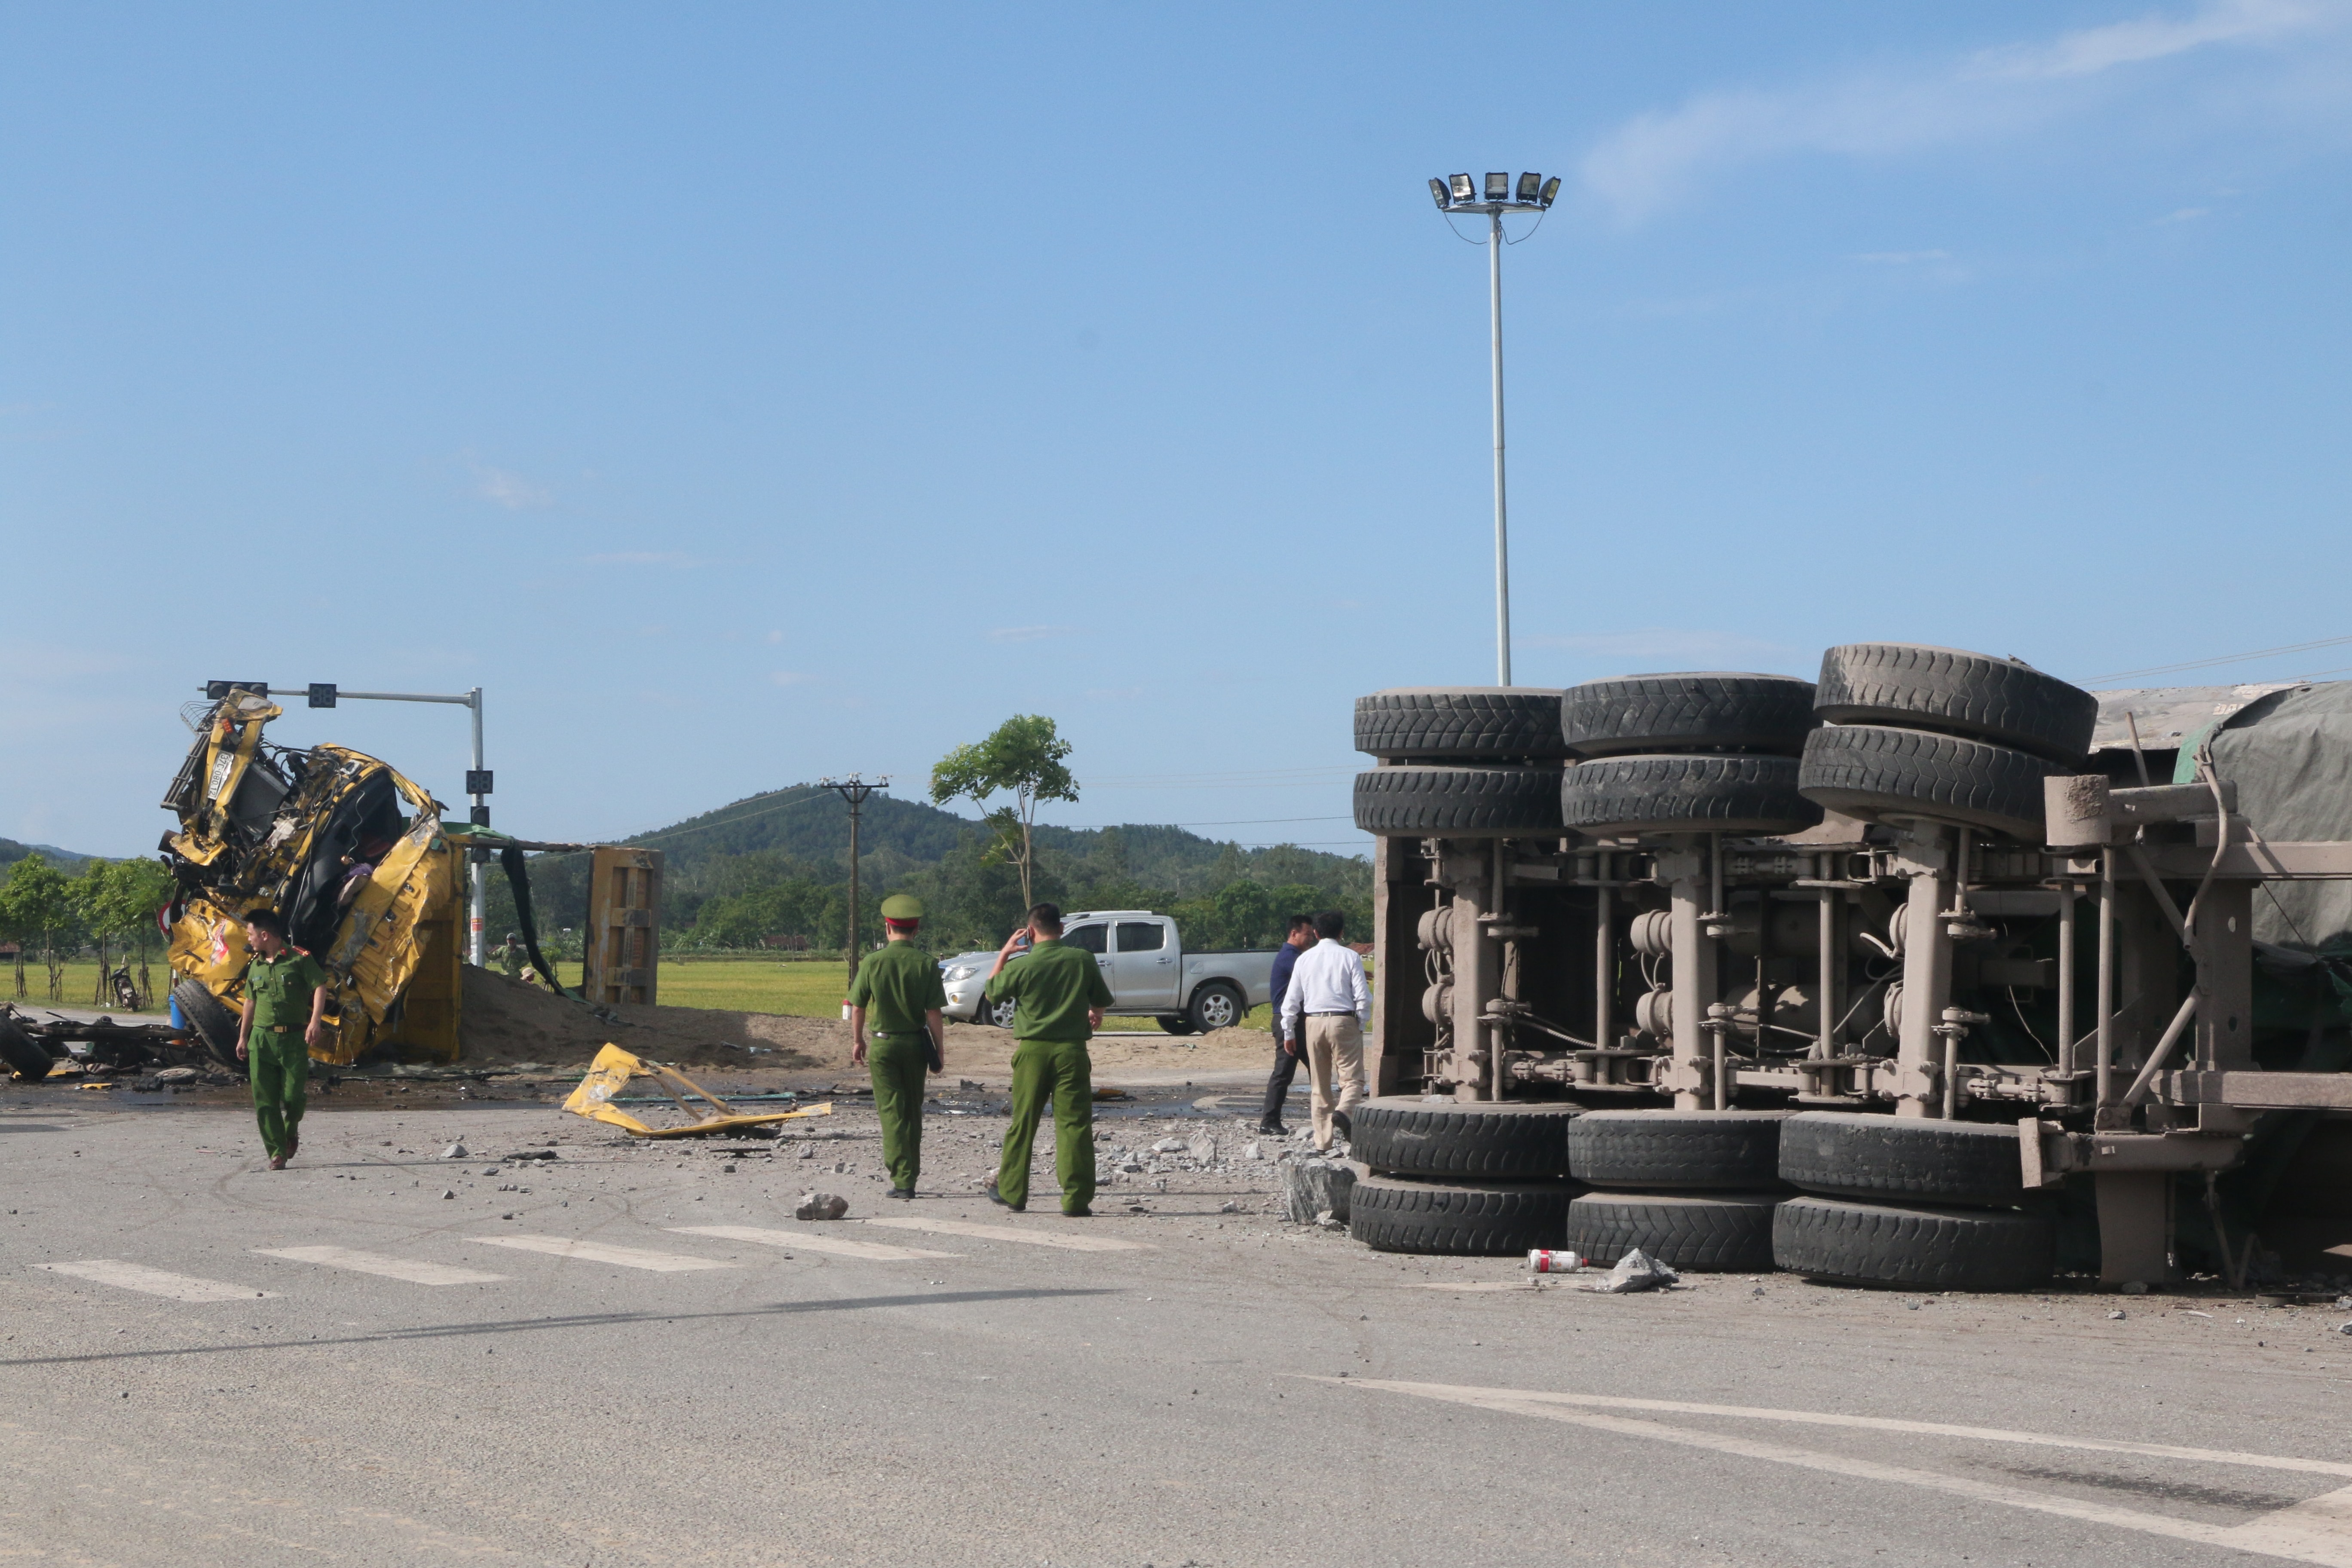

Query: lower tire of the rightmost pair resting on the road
left=1771, top=1199, right=2058, bottom=1291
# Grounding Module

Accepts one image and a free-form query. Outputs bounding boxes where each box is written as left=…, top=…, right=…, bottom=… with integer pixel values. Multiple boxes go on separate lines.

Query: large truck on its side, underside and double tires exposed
left=1350, top=644, right=2352, bottom=1288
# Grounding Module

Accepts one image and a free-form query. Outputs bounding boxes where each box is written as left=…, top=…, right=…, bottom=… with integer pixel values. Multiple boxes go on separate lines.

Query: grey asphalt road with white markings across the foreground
left=0, top=1091, right=2352, bottom=1568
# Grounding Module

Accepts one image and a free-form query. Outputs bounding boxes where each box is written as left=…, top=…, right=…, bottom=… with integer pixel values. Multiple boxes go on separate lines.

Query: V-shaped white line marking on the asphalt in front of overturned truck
left=1312, top=1378, right=2352, bottom=1568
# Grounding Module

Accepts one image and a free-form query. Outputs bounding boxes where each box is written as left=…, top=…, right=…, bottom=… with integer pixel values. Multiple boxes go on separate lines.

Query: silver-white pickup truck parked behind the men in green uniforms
left=938, top=910, right=1275, bottom=1034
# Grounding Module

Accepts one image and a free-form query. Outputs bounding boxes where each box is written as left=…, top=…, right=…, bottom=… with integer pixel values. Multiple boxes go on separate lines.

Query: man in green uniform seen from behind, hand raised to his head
left=983, top=903, right=1110, bottom=1220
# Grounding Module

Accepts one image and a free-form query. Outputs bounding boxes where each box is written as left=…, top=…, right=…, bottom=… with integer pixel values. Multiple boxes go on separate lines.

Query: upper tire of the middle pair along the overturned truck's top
left=1559, top=675, right=1820, bottom=757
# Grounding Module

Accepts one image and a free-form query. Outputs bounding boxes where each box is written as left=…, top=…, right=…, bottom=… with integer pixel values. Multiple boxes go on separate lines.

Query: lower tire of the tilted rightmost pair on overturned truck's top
left=1797, top=724, right=2065, bottom=844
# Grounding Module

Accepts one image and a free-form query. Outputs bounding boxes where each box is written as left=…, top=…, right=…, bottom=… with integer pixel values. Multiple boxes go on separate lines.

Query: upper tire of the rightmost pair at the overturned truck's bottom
left=1780, top=1109, right=2025, bottom=1208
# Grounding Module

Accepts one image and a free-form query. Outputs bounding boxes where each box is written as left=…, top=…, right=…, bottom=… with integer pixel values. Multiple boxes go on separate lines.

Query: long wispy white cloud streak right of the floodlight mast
left=1578, top=0, right=2352, bottom=224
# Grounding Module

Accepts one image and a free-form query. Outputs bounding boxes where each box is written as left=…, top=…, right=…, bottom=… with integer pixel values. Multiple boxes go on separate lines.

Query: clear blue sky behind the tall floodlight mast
left=0, top=0, right=2352, bottom=853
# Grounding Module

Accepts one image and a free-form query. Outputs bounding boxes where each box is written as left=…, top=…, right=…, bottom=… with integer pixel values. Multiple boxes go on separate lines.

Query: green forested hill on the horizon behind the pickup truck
left=489, top=785, right=1371, bottom=950
